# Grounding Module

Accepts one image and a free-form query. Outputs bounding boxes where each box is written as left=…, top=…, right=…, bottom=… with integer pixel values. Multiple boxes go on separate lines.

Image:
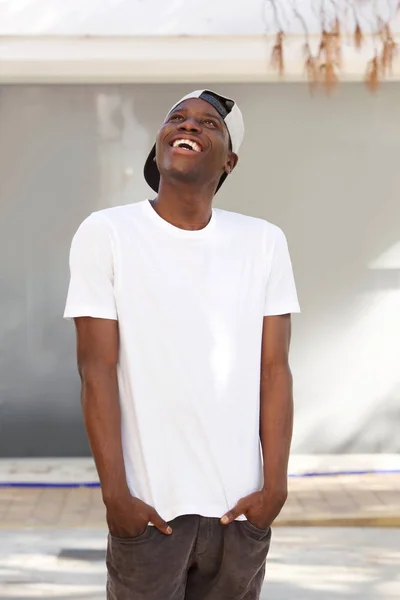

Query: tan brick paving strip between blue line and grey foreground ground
left=0, top=474, right=400, bottom=528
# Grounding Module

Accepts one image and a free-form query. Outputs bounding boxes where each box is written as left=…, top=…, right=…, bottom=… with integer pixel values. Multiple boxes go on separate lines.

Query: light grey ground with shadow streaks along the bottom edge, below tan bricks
left=0, top=527, right=400, bottom=600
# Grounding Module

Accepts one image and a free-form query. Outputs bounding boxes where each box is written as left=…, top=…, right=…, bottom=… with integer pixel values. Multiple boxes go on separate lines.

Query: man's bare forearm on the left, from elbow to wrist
left=81, top=367, right=128, bottom=502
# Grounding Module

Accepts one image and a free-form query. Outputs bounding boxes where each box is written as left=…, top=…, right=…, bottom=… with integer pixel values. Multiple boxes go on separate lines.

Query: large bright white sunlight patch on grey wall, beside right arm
left=296, top=289, right=400, bottom=446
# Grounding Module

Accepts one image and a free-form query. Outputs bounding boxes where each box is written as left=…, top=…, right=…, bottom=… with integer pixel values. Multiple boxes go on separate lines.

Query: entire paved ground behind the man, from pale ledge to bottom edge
left=0, top=456, right=400, bottom=600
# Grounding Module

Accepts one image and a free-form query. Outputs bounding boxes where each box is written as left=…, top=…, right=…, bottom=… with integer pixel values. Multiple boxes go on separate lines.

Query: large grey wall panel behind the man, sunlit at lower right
left=0, top=84, right=400, bottom=456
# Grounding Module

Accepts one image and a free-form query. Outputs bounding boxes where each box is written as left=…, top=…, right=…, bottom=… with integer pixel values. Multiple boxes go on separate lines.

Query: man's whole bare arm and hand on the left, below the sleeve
left=75, top=317, right=172, bottom=538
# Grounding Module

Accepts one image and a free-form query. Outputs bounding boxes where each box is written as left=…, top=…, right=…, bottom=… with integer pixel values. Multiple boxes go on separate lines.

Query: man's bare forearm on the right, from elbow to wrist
left=260, top=365, right=293, bottom=489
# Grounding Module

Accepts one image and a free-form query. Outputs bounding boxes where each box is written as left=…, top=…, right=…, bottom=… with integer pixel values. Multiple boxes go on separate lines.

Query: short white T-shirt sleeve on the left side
left=64, top=213, right=118, bottom=320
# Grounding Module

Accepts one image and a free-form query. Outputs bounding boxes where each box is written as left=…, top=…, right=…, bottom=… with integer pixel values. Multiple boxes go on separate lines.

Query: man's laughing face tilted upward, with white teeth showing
left=156, top=98, right=238, bottom=188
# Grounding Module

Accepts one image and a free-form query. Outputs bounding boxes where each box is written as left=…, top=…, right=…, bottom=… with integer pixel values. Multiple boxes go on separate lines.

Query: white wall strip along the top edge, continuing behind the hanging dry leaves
left=0, top=0, right=400, bottom=36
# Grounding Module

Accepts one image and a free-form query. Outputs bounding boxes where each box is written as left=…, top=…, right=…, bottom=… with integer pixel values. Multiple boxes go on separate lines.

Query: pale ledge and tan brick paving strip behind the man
left=0, top=455, right=400, bottom=528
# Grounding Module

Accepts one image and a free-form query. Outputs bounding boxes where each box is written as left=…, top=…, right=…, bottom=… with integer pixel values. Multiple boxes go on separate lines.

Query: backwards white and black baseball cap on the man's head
left=144, top=90, right=244, bottom=192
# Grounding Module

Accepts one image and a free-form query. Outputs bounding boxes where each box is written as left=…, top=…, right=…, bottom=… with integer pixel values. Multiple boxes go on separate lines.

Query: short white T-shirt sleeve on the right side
left=264, top=228, right=300, bottom=317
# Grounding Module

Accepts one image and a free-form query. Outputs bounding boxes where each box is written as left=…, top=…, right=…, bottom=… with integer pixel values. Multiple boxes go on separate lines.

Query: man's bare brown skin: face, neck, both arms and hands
left=75, top=99, right=293, bottom=538
